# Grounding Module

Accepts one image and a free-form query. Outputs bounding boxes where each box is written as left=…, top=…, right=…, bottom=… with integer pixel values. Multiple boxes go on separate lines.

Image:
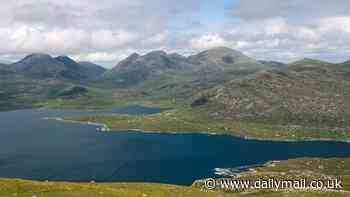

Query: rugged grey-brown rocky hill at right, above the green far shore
left=193, top=61, right=350, bottom=127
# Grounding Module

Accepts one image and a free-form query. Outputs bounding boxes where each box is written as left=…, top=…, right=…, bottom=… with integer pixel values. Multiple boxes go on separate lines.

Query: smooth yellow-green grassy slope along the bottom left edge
left=0, top=179, right=236, bottom=197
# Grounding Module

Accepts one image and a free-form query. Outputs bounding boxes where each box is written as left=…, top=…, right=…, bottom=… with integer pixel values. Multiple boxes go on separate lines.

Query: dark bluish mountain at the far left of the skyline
left=12, top=54, right=105, bottom=80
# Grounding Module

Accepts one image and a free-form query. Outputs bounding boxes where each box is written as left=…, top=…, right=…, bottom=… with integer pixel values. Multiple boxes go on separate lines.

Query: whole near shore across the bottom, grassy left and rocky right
left=0, top=157, right=350, bottom=197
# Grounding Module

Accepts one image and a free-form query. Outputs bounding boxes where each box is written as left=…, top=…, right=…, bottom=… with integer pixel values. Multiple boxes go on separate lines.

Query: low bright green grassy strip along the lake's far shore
left=65, top=105, right=350, bottom=141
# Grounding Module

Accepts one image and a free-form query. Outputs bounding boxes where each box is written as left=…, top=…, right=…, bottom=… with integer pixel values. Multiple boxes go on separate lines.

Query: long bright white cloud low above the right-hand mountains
left=190, top=14, right=350, bottom=62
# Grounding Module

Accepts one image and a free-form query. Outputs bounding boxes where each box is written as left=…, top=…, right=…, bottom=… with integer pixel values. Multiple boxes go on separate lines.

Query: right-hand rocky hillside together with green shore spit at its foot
left=67, top=52, right=350, bottom=141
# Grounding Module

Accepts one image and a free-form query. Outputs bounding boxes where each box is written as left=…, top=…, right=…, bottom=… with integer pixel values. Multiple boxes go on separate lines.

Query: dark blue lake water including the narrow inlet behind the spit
left=0, top=107, right=350, bottom=185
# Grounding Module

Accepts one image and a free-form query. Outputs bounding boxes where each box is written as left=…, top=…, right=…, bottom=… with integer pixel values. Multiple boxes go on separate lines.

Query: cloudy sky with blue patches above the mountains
left=0, top=0, right=350, bottom=67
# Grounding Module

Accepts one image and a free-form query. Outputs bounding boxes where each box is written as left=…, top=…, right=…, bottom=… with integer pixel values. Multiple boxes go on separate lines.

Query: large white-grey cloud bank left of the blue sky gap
left=0, top=0, right=200, bottom=64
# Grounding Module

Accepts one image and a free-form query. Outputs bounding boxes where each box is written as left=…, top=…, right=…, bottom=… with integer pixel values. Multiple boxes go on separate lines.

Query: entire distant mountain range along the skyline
left=0, top=47, right=350, bottom=87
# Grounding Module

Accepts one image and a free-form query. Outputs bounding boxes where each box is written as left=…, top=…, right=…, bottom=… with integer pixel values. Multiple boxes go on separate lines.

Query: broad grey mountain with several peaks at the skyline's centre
left=101, top=47, right=272, bottom=99
